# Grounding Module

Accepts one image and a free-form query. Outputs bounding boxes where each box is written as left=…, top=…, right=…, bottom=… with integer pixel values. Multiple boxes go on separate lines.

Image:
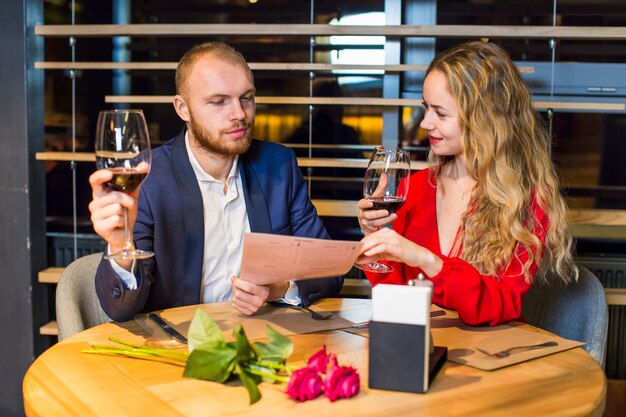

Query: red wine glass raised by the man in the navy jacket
left=96, top=110, right=154, bottom=259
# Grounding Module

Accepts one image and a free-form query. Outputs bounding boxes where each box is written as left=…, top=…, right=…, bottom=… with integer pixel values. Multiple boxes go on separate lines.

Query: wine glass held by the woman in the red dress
left=355, top=146, right=411, bottom=273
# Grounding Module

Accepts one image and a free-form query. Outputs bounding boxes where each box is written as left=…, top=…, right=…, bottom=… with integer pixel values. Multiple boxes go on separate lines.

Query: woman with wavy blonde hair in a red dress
left=358, top=42, right=578, bottom=326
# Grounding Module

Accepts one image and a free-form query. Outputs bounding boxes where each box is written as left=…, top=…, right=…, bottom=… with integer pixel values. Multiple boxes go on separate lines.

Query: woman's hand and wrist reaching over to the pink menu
left=357, top=228, right=443, bottom=277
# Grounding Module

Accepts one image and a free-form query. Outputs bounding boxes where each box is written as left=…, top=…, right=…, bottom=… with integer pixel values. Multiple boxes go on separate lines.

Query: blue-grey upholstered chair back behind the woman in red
left=522, top=266, right=608, bottom=367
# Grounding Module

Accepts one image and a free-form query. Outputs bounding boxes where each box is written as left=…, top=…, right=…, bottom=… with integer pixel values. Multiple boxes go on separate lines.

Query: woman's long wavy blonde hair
left=426, top=42, right=578, bottom=282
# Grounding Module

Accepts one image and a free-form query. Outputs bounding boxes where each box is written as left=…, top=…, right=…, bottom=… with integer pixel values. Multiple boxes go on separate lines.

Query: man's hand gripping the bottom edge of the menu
left=231, top=276, right=289, bottom=316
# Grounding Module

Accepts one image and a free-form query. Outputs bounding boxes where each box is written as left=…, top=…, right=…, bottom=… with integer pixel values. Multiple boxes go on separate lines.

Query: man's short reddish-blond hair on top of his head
left=176, top=42, right=254, bottom=96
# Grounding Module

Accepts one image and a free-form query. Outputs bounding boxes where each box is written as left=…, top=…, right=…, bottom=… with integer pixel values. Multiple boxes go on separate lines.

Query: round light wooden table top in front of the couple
left=23, top=299, right=606, bottom=417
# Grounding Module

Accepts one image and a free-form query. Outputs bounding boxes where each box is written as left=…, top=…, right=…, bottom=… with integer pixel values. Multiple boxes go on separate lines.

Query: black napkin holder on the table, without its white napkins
left=368, top=321, right=448, bottom=393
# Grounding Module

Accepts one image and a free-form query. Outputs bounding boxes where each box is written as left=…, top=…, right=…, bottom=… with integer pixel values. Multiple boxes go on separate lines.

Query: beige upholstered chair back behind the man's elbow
left=56, top=253, right=111, bottom=340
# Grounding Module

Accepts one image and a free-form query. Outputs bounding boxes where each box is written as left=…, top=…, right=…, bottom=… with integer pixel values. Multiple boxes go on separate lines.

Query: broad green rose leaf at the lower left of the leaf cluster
left=183, top=342, right=237, bottom=383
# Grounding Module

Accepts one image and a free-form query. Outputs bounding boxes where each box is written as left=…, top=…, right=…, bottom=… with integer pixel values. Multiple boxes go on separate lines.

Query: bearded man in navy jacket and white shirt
left=89, top=42, right=343, bottom=321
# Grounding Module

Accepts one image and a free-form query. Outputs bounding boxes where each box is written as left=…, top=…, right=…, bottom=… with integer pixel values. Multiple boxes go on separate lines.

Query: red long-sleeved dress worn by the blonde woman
left=366, top=169, right=548, bottom=326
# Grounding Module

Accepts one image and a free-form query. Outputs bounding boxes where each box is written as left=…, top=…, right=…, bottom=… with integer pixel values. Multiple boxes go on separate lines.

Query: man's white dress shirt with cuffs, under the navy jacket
left=111, top=134, right=301, bottom=305
